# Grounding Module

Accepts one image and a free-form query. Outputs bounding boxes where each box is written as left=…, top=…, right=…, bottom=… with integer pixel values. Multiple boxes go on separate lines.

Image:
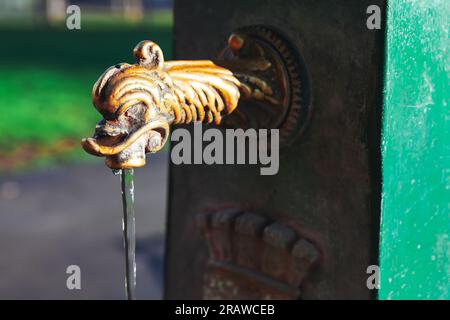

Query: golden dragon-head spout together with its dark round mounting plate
left=82, top=27, right=309, bottom=169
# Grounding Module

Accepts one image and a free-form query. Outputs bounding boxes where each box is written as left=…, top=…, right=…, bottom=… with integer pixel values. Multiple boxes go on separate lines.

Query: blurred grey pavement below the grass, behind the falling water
left=0, top=154, right=167, bottom=299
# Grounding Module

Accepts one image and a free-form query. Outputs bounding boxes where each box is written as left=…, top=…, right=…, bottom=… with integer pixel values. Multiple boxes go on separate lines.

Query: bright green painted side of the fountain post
left=379, top=0, right=450, bottom=299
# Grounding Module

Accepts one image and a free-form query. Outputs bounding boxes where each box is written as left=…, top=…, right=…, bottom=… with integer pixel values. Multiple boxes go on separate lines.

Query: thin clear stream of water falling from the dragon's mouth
left=120, top=169, right=136, bottom=300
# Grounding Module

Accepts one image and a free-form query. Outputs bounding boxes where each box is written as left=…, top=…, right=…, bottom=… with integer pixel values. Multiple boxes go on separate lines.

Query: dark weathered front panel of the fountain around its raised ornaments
left=166, top=0, right=384, bottom=299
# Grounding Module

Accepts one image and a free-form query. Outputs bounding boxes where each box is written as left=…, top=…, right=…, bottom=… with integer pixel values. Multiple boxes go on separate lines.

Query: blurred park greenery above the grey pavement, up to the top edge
left=0, top=0, right=172, bottom=172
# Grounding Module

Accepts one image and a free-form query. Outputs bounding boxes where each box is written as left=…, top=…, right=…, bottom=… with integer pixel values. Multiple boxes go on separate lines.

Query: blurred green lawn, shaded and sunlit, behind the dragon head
left=0, top=13, right=172, bottom=170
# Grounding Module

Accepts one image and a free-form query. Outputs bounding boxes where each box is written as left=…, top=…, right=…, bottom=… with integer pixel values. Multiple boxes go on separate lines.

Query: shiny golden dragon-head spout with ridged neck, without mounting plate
left=81, top=41, right=240, bottom=169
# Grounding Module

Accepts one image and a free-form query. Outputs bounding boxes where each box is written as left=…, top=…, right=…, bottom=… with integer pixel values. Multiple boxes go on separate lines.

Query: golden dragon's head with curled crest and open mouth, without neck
left=81, top=41, right=171, bottom=169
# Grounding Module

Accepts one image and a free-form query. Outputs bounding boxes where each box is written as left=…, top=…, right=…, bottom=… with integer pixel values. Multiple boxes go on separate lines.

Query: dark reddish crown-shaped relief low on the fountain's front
left=198, top=209, right=320, bottom=299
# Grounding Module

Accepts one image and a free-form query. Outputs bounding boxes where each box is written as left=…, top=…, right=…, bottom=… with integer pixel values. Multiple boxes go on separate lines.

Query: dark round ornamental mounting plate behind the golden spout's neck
left=216, top=25, right=311, bottom=143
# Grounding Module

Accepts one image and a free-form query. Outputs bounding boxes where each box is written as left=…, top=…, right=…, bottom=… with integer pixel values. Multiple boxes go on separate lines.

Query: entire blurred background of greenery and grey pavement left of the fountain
left=0, top=0, right=172, bottom=299
